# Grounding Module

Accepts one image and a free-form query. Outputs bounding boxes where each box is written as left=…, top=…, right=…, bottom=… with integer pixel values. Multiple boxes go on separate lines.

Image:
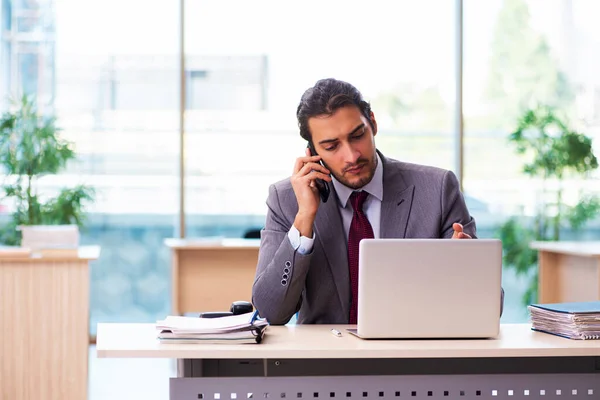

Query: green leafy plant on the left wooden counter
left=0, top=96, right=94, bottom=245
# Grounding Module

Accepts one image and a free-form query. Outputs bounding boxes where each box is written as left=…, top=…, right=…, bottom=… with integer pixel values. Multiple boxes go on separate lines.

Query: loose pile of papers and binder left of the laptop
left=156, top=311, right=268, bottom=344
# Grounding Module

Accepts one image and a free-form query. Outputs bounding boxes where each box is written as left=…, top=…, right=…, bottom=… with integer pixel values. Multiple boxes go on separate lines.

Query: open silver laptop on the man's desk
left=349, top=239, right=502, bottom=339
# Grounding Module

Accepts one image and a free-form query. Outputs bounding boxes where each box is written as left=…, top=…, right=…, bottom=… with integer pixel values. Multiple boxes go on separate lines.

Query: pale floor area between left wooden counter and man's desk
left=88, top=346, right=177, bottom=400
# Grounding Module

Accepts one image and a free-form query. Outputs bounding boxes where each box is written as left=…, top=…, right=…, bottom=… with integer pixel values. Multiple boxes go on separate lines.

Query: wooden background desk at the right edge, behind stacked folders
left=530, top=241, right=600, bottom=303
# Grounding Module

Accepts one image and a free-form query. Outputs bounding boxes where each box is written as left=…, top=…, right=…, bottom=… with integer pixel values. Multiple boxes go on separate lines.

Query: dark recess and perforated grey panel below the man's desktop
left=170, top=356, right=600, bottom=400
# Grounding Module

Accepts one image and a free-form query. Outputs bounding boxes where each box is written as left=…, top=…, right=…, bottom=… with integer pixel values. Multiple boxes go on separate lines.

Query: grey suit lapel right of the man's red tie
left=379, top=153, right=415, bottom=239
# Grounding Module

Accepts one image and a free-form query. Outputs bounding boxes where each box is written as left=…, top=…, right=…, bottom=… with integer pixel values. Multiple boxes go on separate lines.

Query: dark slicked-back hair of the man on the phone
left=296, top=78, right=373, bottom=142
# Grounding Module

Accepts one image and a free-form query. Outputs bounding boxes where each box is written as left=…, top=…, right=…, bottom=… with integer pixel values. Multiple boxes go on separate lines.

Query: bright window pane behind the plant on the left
left=0, top=0, right=179, bottom=334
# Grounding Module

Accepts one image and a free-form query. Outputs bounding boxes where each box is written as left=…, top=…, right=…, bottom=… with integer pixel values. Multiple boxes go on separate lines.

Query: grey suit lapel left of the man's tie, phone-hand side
left=315, top=193, right=350, bottom=315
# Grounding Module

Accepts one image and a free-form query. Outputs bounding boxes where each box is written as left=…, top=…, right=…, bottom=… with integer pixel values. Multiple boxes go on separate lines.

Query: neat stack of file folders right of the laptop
left=528, top=301, right=600, bottom=340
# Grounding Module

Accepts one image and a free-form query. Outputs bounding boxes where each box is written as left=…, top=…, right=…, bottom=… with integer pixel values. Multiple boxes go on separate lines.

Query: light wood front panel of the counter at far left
left=0, top=260, right=89, bottom=400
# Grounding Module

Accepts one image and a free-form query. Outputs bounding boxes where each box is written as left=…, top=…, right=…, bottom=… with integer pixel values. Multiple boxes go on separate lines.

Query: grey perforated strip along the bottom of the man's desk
left=170, top=373, right=600, bottom=400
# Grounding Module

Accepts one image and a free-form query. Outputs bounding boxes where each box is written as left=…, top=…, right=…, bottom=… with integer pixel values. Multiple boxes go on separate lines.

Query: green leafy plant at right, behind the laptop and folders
left=498, top=107, right=600, bottom=304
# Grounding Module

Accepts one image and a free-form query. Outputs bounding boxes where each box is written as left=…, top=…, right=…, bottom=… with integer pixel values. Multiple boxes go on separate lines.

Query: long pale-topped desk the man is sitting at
left=97, top=324, right=600, bottom=400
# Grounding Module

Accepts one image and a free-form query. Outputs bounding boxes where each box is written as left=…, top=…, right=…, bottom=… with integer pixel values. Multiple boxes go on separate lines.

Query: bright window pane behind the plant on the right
left=464, top=0, right=600, bottom=322
